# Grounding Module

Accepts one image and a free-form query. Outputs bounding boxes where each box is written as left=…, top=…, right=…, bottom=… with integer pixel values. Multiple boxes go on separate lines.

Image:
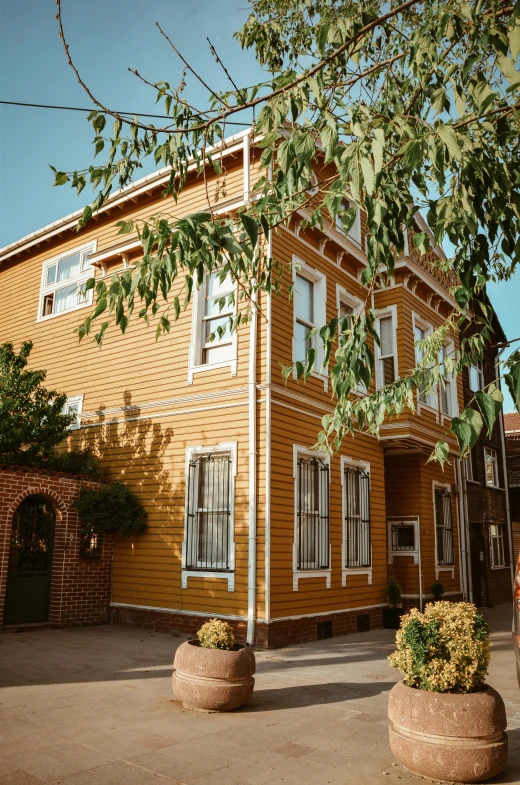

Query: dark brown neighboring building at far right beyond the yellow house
left=459, top=322, right=514, bottom=607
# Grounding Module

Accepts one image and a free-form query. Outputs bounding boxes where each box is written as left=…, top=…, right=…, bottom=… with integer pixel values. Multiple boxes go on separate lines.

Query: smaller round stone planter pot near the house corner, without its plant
left=172, top=641, right=255, bottom=711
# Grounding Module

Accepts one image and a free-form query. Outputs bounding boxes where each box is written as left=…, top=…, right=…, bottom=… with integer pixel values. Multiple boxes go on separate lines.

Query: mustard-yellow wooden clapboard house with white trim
left=0, top=132, right=503, bottom=645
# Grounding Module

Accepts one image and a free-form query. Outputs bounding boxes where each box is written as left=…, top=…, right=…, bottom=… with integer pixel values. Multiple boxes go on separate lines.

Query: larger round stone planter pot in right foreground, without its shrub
left=388, top=681, right=507, bottom=782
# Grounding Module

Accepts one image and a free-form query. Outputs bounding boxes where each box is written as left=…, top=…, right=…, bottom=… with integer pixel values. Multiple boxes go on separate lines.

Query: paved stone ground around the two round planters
left=0, top=605, right=520, bottom=785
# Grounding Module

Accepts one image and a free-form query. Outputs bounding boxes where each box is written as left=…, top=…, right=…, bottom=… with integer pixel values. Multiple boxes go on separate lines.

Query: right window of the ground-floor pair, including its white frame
left=341, top=456, right=372, bottom=586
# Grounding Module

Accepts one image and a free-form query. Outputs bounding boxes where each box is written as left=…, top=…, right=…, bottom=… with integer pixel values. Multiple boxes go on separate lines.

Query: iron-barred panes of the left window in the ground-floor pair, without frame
left=296, top=457, right=330, bottom=570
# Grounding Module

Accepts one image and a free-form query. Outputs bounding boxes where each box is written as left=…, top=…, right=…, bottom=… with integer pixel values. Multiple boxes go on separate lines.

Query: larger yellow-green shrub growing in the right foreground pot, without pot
left=388, top=602, right=489, bottom=693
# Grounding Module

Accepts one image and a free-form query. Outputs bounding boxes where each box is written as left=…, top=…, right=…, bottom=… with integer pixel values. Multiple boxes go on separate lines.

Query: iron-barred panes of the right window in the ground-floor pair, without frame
left=343, top=466, right=371, bottom=568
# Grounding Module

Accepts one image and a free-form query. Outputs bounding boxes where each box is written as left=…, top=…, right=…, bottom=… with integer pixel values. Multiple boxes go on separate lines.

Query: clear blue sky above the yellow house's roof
left=0, top=0, right=520, bottom=411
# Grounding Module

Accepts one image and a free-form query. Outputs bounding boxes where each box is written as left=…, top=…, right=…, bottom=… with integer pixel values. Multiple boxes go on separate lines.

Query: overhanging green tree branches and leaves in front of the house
left=55, top=0, right=520, bottom=463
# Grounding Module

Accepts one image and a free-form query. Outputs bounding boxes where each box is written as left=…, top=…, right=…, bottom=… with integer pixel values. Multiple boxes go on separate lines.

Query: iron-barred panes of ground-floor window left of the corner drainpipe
left=185, top=453, right=232, bottom=570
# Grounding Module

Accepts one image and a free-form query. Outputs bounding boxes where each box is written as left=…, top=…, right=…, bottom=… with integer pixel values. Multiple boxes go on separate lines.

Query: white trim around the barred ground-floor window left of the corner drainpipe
left=181, top=442, right=237, bottom=591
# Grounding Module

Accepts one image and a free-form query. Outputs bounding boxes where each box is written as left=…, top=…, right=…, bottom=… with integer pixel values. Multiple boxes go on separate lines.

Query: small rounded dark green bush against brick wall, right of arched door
left=72, top=482, right=146, bottom=537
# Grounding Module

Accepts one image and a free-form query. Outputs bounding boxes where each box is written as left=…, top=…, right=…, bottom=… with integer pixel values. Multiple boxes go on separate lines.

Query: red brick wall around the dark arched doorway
left=0, top=467, right=113, bottom=628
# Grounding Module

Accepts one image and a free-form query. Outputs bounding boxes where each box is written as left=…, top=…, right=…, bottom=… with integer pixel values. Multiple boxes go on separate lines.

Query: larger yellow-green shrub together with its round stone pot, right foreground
left=388, top=602, right=507, bottom=782
